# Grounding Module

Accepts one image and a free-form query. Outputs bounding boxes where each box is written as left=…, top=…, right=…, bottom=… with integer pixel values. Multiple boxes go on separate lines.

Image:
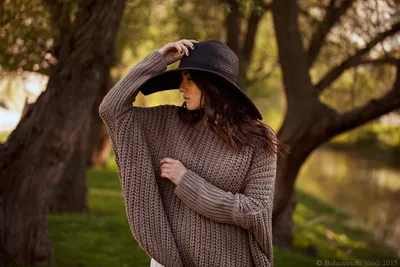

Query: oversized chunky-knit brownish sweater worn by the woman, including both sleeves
left=99, top=50, right=277, bottom=267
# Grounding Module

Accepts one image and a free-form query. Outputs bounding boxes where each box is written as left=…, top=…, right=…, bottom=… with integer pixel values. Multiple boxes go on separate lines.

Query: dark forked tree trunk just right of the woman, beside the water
left=272, top=0, right=335, bottom=247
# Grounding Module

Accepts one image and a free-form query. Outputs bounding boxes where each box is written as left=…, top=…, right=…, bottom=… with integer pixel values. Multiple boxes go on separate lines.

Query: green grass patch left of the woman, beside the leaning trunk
left=49, top=170, right=150, bottom=267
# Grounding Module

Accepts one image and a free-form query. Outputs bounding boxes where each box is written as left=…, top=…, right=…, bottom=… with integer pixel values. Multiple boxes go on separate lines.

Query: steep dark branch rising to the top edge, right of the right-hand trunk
left=308, top=0, right=355, bottom=67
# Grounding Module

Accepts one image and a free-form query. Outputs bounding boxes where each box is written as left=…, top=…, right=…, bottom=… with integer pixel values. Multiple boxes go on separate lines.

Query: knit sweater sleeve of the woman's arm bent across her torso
left=175, top=142, right=277, bottom=261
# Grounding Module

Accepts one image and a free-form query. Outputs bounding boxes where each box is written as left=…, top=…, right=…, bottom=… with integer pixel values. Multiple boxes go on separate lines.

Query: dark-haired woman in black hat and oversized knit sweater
left=99, top=39, right=283, bottom=267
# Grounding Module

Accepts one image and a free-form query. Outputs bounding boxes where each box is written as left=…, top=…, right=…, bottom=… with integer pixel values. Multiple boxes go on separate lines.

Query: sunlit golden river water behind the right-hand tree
left=296, top=148, right=400, bottom=254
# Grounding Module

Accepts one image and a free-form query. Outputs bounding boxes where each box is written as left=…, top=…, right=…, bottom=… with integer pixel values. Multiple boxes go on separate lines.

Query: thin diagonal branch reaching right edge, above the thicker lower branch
left=315, top=22, right=400, bottom=94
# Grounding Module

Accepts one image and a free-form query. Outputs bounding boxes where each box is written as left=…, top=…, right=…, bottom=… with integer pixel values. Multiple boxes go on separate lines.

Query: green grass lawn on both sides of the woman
left=42, top=169, right=400, bottom=267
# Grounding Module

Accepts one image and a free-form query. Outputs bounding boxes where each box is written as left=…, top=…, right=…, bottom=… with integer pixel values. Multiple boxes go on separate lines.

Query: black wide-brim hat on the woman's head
left=139, top=40, right=262, bottom=120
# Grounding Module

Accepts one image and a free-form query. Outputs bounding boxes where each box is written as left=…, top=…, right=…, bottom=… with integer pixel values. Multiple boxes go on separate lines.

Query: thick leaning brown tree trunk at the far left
left=0, top=0, right=125, bottom=265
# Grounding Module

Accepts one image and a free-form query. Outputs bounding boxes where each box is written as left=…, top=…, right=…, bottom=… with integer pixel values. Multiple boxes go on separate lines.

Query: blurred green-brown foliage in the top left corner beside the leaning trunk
left=0, top=0, right=56, bottom=72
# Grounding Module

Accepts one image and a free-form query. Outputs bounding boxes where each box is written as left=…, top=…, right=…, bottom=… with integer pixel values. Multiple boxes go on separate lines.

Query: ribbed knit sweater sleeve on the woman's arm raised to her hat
left=99, top=50, right=167, bottom=130
